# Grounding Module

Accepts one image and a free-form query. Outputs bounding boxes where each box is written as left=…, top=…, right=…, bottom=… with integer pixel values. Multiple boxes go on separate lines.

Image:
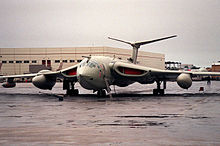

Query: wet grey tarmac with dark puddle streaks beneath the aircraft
left=0, top=82, right=220, bottom=146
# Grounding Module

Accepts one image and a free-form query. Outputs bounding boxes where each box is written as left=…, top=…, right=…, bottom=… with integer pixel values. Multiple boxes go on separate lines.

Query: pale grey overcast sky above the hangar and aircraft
left=0, top=0, right=220, bottom=66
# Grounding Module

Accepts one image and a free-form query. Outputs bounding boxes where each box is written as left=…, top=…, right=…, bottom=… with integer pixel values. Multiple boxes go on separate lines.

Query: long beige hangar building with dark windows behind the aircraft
left=0, top=47, right=165, bottom=75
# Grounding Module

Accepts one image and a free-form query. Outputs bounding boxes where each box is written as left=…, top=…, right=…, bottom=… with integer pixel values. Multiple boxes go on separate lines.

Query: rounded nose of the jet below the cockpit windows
left=77, top=66, right=105, bottom=90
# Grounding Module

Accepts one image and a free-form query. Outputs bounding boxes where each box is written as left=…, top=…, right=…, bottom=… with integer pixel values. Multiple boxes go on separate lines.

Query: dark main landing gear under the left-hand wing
left=63, top=79, right=79, bottom=96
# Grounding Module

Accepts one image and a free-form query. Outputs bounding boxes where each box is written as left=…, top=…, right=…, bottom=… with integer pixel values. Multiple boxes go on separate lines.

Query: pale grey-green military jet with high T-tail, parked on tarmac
left=0, top=35, right=220, bottom=97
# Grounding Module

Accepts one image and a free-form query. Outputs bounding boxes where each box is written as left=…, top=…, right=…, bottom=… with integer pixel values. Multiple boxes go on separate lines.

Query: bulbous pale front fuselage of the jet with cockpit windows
left=77, top=56, right=114, bottom=91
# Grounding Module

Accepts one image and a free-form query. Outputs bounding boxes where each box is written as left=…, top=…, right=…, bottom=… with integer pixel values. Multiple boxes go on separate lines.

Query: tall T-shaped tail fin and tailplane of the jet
left=108, top=35, right=177, bottom=64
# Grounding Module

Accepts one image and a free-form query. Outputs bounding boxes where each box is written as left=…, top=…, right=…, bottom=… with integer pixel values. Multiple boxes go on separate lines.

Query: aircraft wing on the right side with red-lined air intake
left=111, top=61, right=220, bottom=83
